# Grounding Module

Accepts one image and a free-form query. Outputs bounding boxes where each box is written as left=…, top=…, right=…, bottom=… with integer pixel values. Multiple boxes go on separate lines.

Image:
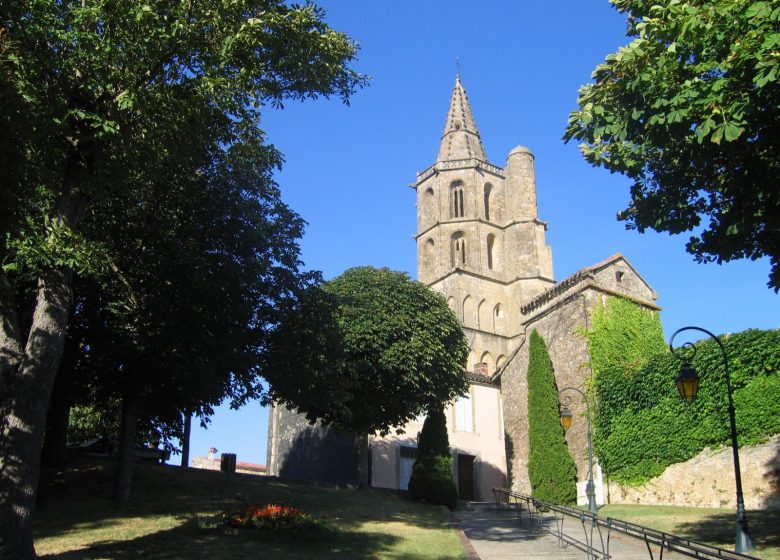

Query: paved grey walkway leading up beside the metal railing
left=452, top=502, right=685, bottom=560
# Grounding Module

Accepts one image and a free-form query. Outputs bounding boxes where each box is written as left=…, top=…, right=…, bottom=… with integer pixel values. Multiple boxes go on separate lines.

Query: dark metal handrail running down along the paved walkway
left=493, top=488, right=759, bottom=560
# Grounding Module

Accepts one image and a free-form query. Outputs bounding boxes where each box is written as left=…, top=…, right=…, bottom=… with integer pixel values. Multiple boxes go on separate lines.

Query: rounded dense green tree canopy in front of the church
left=263, top=267, right=468, bottom=435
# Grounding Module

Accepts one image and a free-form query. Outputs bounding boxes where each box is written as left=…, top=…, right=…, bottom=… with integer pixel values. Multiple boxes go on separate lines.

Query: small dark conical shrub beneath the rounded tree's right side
left=409, top=406, right=458, bottom=508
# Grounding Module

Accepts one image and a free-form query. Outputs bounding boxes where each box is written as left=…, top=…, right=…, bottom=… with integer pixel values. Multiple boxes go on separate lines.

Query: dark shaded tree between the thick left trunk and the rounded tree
left=64, top=142, right=318, bottom=499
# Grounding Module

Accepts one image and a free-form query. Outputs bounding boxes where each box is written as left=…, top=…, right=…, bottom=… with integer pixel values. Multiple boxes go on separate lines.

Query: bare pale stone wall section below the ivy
left=606, top=435, right=780, bottom=509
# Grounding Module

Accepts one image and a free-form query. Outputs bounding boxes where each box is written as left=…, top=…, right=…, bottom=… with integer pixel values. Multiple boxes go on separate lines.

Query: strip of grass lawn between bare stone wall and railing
left=599, top=505, right=780, bottom=560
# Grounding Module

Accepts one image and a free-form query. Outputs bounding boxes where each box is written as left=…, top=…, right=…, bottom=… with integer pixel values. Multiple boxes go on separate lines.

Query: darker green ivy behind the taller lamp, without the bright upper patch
left=594, top=330, right=780, bottom=484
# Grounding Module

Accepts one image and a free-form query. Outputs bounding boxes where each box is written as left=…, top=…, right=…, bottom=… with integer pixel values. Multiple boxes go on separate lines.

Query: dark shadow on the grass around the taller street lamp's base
left=677, top=509, right=780, bottom=548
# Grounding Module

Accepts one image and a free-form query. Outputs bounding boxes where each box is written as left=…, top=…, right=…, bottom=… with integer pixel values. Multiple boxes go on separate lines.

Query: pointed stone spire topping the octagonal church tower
left=436, top=75, right=487, bottom=161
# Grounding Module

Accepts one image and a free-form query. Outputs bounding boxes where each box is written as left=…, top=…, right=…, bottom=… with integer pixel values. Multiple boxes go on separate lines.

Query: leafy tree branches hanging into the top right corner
left=564, top=0, right=780, bottom=291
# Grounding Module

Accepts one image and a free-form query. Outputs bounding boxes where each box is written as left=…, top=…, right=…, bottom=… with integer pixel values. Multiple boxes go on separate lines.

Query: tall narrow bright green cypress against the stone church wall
left=528, top=330, right=577, bottom=504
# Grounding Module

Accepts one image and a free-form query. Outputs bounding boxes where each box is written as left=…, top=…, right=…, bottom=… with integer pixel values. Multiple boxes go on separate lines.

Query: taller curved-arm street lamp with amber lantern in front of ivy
left=669, top=327, right=753, bottom=552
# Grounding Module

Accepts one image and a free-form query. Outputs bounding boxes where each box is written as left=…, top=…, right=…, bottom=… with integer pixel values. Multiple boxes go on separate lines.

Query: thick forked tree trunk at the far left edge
left=0, top=123, right=92, bottom=560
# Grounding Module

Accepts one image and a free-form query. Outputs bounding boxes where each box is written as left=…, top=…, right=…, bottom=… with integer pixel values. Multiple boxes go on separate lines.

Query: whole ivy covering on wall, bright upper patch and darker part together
left=588, top=299, right=780, bottom=484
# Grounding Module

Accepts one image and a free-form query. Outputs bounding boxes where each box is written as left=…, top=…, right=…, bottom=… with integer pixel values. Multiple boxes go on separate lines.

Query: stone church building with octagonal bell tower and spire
left=268, top=76, right=659, bottom=502
